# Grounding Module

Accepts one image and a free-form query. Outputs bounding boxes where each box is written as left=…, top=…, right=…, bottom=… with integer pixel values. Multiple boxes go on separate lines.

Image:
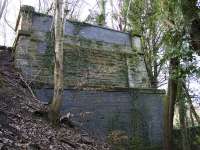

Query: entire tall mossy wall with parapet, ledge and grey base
left=14, top=6, right=164, bottom=150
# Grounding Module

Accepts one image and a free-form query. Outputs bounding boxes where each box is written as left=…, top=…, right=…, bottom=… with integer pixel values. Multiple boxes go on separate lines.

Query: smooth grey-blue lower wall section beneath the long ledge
left=36, top=89, right=164, bottom=145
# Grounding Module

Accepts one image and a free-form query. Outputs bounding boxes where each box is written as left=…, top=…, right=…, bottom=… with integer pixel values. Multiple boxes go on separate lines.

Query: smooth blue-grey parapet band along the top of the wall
left=32, top=15, right=131, bottom=47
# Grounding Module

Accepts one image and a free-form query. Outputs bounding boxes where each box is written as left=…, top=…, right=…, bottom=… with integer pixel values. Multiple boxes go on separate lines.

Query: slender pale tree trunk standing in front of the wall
left=49, top=0, right=64, bottom=125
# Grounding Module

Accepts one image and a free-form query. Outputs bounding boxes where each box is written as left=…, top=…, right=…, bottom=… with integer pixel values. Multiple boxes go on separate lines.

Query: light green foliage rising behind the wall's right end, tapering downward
left=124, top=0, right=167, bottom=88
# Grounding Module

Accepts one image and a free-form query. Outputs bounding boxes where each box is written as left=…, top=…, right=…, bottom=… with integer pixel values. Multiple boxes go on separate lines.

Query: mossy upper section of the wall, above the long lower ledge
left=14, top=6, right=148, bottom=89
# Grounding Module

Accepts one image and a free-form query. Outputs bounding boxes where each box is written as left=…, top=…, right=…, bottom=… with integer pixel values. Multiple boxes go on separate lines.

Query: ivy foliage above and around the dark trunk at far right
left=159, top=0, right=200, bottom=78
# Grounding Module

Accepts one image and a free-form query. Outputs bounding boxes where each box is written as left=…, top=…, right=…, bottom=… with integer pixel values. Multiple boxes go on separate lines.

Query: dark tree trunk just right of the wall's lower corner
left=165, top=58, right=179, bottom=150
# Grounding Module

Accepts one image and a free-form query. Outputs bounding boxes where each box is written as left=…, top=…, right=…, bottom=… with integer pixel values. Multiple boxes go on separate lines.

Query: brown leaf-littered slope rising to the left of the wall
left=0, top=49, right=109, bottom=150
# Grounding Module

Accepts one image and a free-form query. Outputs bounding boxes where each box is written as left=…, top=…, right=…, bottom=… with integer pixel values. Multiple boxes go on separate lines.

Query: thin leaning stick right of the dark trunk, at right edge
left=182, top=83, right=200, bottom=125
